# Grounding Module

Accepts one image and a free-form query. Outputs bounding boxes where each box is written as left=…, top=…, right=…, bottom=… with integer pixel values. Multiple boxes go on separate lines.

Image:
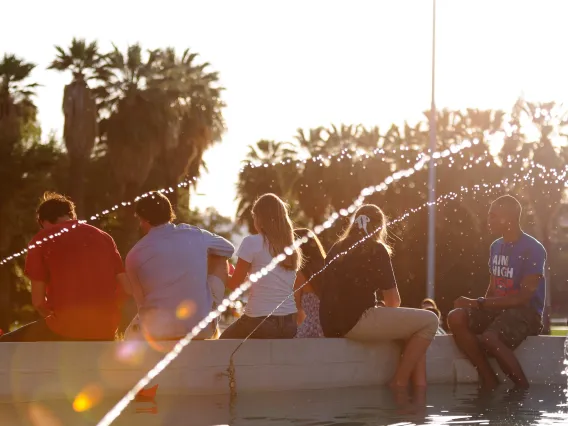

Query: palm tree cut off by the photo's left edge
left=0, top=54, right=54, bottom=330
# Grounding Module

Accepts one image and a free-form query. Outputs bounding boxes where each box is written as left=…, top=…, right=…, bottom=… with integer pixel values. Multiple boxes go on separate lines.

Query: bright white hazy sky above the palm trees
left=0, top=0, right=568, bottom=216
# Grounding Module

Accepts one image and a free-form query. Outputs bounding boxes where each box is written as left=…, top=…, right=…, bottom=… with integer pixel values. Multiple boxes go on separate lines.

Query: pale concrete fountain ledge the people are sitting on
left=0, top=336, right=566, bottom=401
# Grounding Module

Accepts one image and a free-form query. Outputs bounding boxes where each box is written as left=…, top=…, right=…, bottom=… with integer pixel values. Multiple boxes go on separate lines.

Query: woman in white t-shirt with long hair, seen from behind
left=220, top=194, right=302, bottom=339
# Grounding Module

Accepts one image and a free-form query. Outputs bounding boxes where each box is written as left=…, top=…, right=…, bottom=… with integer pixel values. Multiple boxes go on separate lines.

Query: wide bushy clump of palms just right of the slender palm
left=101, top=44, right=224, bottom=250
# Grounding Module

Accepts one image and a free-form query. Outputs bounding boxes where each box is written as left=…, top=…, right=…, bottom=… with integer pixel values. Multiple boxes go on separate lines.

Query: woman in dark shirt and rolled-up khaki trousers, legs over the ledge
left=320, top=205, right=438, bottom=388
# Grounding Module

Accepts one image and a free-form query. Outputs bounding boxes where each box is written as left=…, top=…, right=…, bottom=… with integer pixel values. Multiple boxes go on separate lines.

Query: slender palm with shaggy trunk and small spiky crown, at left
left=48, top=38, right=106, bottom=217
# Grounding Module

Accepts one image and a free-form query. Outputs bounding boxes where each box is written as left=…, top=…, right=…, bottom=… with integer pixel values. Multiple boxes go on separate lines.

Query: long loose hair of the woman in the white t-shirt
left=252, top=194, right=302, bottom=271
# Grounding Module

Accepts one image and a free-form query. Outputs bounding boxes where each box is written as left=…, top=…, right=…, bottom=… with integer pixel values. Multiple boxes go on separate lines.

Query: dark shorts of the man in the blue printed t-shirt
left=466, top=307, right=542, bottom=349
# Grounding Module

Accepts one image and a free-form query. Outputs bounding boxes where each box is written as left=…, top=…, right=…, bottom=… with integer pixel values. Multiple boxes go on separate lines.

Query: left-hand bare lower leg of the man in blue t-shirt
left=448, top=309, right=499, bottom=389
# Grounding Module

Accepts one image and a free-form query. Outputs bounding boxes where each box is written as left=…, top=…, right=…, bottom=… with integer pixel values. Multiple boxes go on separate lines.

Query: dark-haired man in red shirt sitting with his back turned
left=0, top=193, right=130, bottom=342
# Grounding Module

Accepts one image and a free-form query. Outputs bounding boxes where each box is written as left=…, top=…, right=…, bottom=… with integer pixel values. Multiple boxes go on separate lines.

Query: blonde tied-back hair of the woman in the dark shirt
left=339, top=204, right=392, bottom=256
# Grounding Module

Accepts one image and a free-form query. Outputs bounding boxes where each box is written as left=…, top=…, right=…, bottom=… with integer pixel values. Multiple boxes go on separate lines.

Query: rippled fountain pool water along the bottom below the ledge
left=0, top=385, right=568, bottom=426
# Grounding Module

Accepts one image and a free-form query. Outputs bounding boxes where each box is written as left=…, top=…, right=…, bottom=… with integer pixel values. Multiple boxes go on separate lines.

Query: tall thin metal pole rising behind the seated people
left=427, top=0, right=436, bottom=299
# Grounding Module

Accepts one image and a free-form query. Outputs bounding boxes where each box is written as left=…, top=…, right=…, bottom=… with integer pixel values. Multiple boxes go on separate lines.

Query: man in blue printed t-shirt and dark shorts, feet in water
left=448, top=195, right=546, bottom=388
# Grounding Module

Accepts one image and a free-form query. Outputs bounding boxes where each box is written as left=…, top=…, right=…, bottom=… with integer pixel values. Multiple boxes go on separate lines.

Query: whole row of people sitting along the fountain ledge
left=0, top=192, right=546, bottom=387
